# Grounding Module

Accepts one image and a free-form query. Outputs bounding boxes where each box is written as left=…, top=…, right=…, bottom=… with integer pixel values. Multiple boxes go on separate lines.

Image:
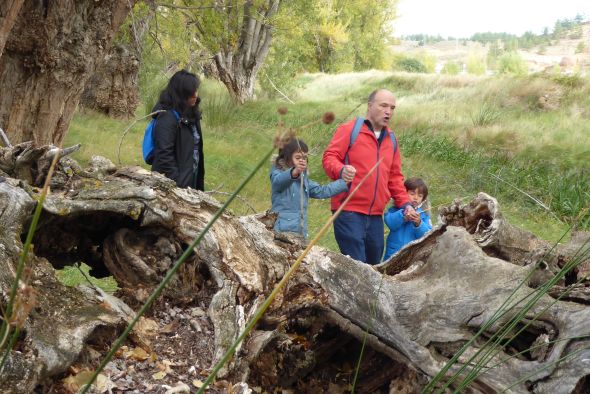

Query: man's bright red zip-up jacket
left=322, top=119, right=410, bottom=215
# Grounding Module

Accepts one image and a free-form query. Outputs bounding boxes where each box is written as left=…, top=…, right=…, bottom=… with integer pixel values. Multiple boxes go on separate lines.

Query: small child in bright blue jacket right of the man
left=383, top=178, right=432, bottom=261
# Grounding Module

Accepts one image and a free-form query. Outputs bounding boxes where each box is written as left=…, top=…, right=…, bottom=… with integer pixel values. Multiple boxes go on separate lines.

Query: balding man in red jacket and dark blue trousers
left=322, top=89, right=416, bottom=264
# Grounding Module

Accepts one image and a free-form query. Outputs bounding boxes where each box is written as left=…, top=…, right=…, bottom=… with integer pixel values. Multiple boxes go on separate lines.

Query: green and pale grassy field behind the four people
left=67, top=71, right=590, bottom=248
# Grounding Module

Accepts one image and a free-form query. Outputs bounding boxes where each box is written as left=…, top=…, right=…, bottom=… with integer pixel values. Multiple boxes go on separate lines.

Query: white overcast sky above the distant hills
left=394, top=0, right=590, bottom=38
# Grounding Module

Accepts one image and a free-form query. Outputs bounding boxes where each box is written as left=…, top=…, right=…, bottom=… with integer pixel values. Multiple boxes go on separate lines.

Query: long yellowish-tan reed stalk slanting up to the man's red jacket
left=197, top=158, right=383, bottom=394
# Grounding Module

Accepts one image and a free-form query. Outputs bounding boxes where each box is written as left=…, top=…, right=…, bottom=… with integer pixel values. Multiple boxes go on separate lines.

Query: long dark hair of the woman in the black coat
left=158, top=70, right=201, bottom=119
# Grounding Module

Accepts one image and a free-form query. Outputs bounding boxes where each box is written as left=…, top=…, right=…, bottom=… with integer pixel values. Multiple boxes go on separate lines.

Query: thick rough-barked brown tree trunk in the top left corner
left=0, top=0, right=135, bottom=144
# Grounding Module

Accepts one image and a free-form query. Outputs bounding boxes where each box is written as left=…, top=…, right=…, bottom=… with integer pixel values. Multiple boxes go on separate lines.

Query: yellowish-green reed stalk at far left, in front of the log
left=0, top=151, right=61, bottom=373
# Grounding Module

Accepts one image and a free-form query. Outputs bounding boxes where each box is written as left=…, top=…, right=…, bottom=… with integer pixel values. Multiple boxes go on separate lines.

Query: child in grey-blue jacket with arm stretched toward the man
left=270, top=138, right=347, bottom=238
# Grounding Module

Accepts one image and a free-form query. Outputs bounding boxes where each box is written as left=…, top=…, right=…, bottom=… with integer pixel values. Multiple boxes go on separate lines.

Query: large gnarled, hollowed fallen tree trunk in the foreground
left=0, top=144, right=590, bottom=393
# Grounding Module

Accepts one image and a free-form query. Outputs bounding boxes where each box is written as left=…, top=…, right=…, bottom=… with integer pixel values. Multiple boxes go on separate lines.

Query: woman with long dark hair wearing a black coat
left=152, top=70, right=205, bottom=190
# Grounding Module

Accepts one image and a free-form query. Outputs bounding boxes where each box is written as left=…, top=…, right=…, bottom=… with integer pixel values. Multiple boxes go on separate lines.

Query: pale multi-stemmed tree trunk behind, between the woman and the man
left=208, top=0, right=280, bottom=104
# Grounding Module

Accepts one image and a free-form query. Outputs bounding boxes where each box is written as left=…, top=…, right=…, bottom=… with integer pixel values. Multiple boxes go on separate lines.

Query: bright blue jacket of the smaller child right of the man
left=383, top=207, right=432, bottom=261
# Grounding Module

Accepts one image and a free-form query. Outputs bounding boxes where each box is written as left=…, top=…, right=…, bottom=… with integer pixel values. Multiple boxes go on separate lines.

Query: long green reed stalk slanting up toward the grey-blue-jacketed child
left=81, top=147, right=275, bottom=394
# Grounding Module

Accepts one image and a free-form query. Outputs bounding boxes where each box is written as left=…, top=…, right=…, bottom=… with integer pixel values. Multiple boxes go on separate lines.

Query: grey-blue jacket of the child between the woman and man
left=270, top=165, right=348, bottom=238
